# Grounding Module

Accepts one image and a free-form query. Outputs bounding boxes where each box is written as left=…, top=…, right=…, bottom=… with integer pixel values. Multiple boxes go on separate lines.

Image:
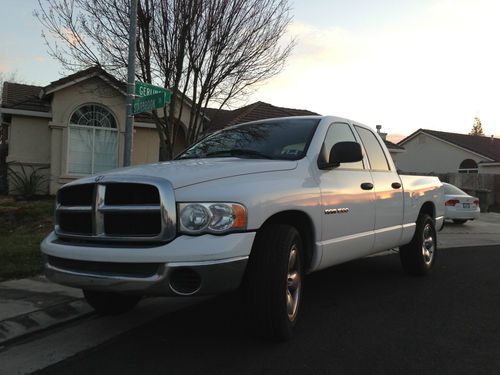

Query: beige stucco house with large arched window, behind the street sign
left=0, top=67, right=190, bottom=194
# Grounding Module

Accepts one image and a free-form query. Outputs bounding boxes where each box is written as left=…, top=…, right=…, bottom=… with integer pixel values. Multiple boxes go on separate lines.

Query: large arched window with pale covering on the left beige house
left=68, top=104, right=118, bottom=175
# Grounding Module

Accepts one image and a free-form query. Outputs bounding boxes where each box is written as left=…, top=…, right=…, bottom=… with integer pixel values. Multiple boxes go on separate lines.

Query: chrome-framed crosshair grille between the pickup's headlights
left=55, top=176, right=176, bottom=242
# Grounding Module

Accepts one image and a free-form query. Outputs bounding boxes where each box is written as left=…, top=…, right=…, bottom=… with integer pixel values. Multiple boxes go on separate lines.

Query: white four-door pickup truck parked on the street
left=41, top=116, right=444, bottom=339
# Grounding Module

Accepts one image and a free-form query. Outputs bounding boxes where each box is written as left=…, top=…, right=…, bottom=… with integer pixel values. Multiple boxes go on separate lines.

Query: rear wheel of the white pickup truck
left=399, top=214, right=437, bottom=276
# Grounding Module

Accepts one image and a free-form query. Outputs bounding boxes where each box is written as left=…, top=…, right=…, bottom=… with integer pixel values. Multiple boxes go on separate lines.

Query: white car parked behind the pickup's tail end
left=443, top=182, right=481, bottom=224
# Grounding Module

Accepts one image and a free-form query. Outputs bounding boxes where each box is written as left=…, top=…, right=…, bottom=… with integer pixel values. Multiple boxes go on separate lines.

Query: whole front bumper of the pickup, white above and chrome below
left=41, top=232, right=255, bottom=296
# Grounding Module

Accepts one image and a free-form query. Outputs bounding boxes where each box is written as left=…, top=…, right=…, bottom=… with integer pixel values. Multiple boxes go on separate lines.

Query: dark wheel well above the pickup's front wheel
left=257, top=210, right=314, bottom=272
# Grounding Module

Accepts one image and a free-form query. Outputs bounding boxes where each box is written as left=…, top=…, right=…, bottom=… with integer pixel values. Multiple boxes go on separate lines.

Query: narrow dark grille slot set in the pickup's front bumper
left=47, top=255, right=160, bottom=278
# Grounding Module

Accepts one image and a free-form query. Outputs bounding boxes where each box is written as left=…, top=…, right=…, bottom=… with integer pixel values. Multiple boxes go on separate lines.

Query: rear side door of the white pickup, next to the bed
left=354, top=125, right=404, bottom=252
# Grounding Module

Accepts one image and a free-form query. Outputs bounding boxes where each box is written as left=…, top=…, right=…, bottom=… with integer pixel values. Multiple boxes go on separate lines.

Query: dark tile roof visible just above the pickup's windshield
left=205, top=101, right=318, bottom=131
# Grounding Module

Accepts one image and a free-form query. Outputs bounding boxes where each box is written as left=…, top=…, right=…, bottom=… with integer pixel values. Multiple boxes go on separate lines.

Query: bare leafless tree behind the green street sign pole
left=35, top=0, right=293, bottom=160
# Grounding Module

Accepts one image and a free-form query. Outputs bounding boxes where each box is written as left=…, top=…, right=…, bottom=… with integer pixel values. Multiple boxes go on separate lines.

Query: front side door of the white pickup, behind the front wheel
left=318, top=122, right=375, bottom=268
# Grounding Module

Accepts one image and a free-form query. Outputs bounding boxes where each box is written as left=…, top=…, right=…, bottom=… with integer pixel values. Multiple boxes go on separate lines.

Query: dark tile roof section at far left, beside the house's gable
left=2, top=82, right=50, bottom=113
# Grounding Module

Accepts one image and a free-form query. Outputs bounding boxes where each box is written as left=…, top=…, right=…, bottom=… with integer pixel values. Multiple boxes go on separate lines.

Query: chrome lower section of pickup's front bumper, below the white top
left=44, top=256, right=248, bottom=296
